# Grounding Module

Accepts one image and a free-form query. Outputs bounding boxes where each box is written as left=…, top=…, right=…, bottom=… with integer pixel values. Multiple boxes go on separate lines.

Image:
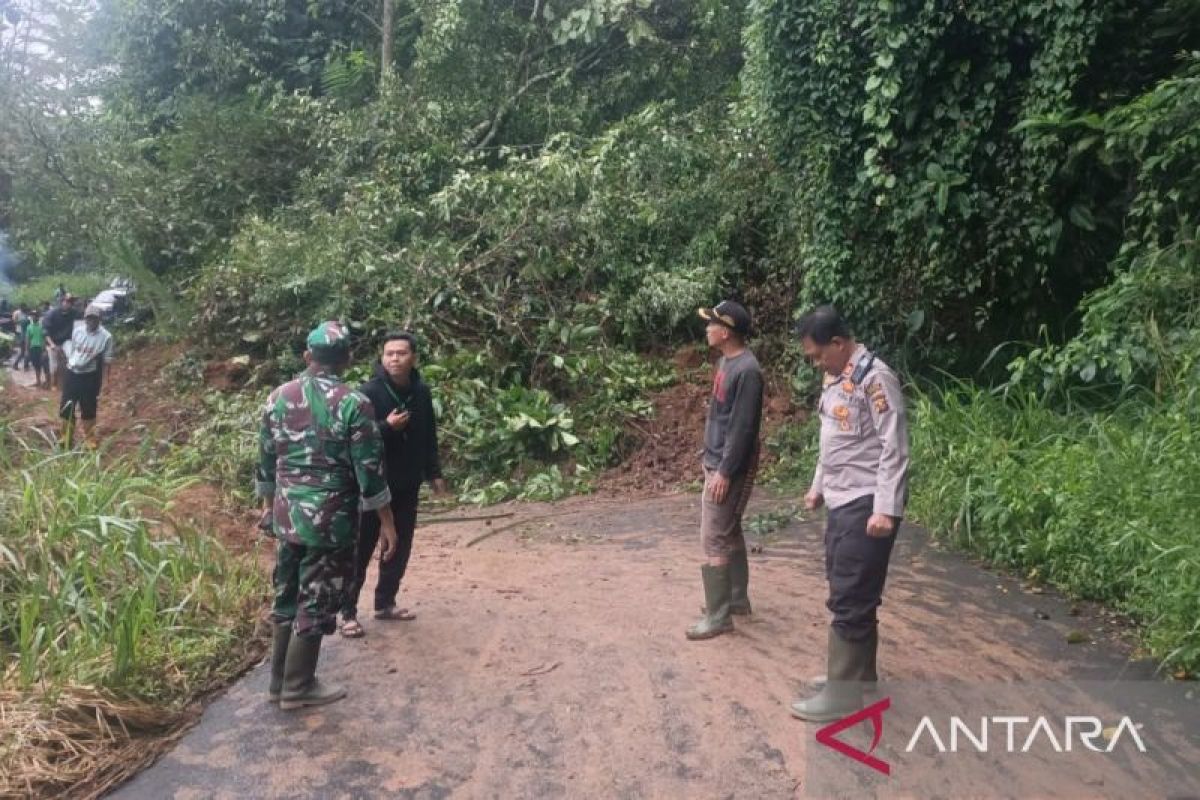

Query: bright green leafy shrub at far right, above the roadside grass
left=1009, top=54, right=1200, bottom=395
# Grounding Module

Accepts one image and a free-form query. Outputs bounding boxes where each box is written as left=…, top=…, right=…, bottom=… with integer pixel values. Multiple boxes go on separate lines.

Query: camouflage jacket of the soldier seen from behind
left=254, top=367, right=391, bottom=547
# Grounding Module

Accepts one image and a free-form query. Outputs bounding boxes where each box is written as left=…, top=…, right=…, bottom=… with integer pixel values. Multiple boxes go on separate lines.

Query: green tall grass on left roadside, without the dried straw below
left=0, top=426, right=262, bottom=697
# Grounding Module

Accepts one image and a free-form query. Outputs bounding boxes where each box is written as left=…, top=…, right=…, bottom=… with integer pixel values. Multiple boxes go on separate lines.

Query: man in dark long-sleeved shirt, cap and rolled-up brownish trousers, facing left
left=688, top=300, right=762, bottom=639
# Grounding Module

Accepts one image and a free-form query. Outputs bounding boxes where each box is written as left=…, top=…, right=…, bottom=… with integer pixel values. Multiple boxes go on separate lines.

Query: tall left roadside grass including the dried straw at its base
left=0, top=420, right=265, bottom=794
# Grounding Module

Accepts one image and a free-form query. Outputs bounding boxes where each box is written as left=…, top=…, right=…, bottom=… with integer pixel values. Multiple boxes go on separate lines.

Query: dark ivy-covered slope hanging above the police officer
left=751, top=0, right=1200, bottom=364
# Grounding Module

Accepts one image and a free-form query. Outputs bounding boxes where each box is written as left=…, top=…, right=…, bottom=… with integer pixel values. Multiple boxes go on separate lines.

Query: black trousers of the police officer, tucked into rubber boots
left=826, top=494, right=899, bottom=642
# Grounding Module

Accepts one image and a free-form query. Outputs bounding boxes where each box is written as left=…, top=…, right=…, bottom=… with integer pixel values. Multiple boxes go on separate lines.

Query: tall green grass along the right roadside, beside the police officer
left=911, top=384, right=1200, bottom=673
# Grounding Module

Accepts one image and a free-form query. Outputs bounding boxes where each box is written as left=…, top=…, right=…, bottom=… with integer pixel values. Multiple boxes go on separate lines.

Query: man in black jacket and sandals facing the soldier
left=342, top=332, right=448, bottom=638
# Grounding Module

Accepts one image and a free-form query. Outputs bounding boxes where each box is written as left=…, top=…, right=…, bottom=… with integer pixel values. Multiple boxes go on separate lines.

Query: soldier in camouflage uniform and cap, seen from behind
left=256, top=323, right=396, bottom=709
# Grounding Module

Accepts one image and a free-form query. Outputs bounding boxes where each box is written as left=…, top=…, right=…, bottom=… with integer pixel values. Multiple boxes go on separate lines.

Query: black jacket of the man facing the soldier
left=359, top=363, right=442, bottom=489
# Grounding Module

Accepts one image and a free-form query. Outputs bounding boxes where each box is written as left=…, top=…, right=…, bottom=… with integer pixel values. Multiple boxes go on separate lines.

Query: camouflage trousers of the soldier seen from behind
left=271, top=541, right=354, bottom=637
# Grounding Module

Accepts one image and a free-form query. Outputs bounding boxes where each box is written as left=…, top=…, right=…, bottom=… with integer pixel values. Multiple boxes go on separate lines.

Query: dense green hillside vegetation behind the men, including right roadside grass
left=0, top=0, right=1200, bottom=690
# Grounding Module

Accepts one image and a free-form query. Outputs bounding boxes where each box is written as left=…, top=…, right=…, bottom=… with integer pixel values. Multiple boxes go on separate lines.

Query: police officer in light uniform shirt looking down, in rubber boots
left=792, top=306, right=908, bottom=722
